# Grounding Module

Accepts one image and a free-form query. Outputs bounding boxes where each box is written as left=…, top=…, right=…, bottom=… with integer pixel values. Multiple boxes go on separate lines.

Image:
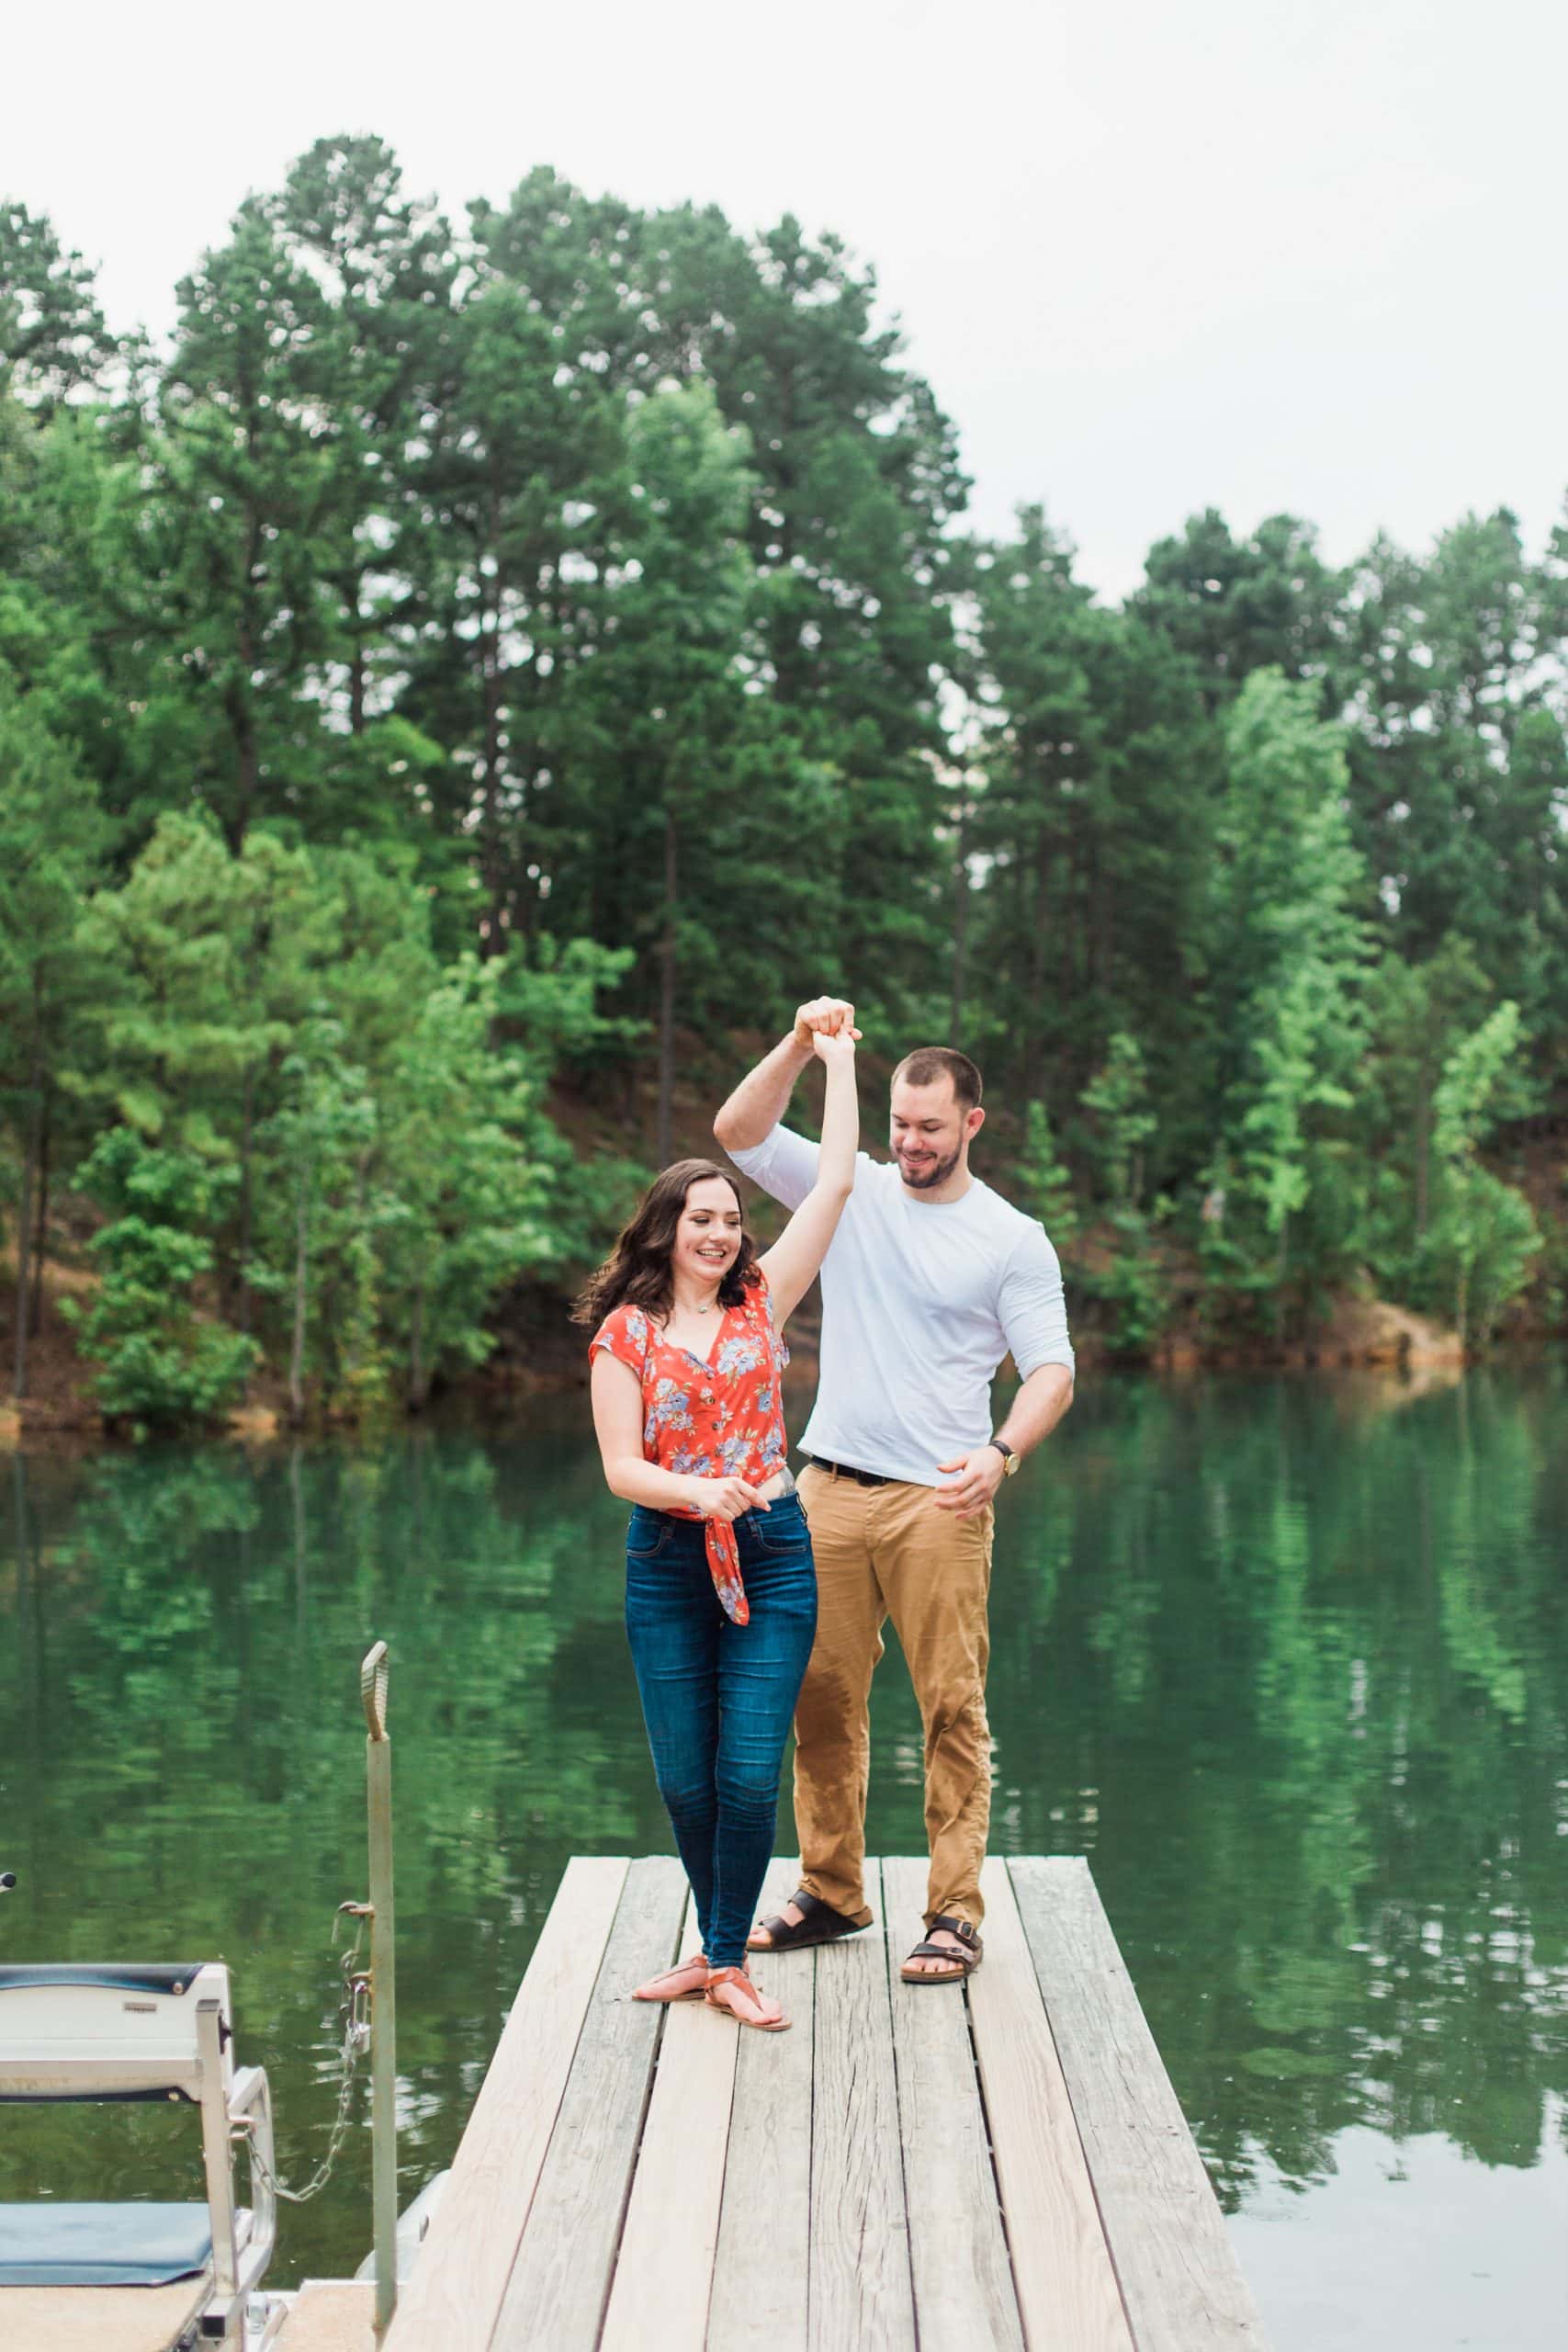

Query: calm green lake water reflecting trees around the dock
left=0, top=1364, right=1568, bottom=2352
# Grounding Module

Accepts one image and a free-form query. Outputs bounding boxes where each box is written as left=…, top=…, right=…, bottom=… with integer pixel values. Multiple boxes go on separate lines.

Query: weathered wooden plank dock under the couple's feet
left=386, top=1856, right=1265, bottom=2352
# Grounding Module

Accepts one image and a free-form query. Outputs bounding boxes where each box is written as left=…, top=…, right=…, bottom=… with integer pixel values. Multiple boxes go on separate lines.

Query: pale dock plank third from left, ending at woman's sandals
left=602, top=1917, right=747, bottom=2352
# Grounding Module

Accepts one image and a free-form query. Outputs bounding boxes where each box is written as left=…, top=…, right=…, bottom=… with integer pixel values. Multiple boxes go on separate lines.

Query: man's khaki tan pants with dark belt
left=795, top=1467, right=992, bottom=1927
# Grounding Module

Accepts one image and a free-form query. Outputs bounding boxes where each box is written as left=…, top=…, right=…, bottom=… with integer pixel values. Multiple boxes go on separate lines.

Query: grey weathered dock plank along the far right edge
left=1006, top=1856, right=1265, bottom=2352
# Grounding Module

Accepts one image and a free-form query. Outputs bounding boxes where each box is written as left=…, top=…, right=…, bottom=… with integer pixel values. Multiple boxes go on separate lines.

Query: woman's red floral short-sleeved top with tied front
left=588, top=1270, right=790, bottom=1625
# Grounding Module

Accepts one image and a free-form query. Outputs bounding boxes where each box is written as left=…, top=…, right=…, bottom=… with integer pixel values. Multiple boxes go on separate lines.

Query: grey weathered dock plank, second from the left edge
left=491, top=1856, right=686, bottom=2352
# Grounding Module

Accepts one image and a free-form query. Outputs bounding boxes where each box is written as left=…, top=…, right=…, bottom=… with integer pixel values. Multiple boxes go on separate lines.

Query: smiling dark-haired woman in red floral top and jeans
left=573, top=1028, right=858, bottom=2032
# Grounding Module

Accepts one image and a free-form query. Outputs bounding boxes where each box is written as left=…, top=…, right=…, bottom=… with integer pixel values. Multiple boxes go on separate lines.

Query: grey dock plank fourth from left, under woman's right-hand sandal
left=707, top=1860, right=818, bottom=2352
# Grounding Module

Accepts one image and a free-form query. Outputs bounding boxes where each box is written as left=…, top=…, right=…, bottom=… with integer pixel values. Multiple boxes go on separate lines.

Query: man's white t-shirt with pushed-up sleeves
left=728, top=1126, right=1072, bottom=1487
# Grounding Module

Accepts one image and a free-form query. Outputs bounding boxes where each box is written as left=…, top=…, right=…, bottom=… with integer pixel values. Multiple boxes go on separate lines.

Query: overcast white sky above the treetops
left=12, top=0, right=1568, bottom=593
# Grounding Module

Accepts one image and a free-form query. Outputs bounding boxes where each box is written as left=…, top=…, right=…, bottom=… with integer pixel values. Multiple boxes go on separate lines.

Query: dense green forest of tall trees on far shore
left=0, top=139, right=1568, bottom=1430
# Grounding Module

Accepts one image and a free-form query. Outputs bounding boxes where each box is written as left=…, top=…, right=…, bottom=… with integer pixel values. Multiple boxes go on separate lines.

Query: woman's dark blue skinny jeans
left=626, top=1494, right=816, bottom=1969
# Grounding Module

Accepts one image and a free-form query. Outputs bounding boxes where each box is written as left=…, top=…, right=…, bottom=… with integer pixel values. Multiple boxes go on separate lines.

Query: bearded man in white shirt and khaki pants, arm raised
left=712, top=997, right=1072, bottom=1983
